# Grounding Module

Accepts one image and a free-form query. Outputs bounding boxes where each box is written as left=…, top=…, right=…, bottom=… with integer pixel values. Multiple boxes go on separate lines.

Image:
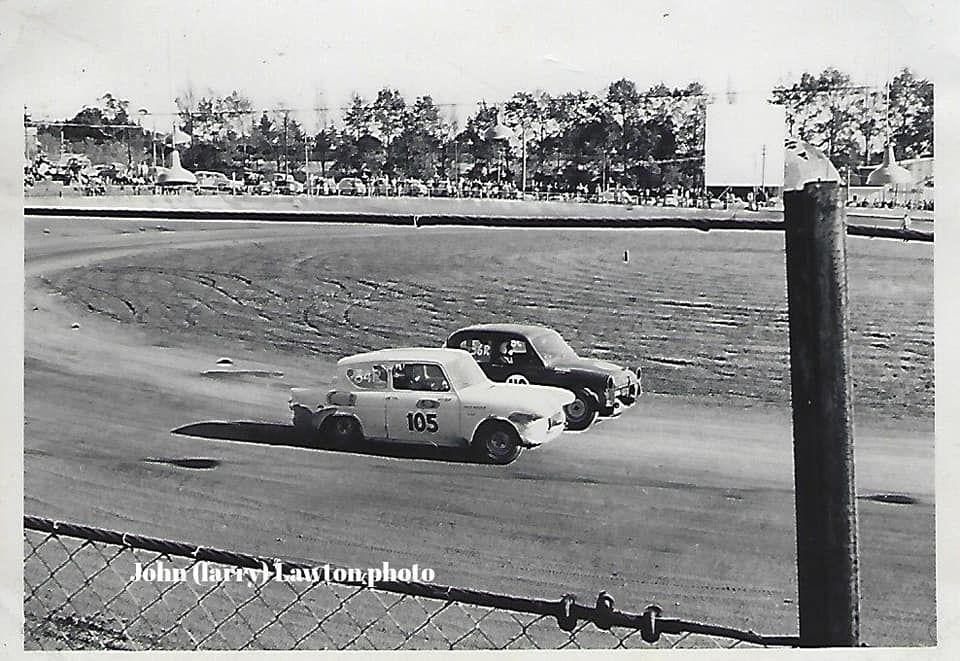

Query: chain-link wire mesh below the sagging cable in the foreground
left=23, top=516, right=800, bottom=650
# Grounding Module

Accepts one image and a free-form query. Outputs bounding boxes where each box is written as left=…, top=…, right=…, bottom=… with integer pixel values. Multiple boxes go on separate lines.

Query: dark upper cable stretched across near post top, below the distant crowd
left=23, top=205, right=933, bottom=242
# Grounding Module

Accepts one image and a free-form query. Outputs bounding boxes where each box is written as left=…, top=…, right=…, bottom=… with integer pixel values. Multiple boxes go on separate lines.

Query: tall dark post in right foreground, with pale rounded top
left=783, top=143, right=860, bottom=647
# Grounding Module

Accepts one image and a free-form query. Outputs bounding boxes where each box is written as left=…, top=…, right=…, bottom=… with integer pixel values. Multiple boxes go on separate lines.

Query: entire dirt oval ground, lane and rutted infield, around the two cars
left=24, top=218, right=936, bottom=646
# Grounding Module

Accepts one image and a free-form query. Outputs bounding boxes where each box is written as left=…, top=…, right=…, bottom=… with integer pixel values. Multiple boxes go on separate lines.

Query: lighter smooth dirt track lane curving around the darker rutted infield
left=24, top=219, right=935, bottom=645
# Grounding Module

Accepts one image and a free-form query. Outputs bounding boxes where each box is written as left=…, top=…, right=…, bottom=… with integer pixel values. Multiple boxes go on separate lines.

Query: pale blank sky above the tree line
left=5, top=0, right=960, bottom=127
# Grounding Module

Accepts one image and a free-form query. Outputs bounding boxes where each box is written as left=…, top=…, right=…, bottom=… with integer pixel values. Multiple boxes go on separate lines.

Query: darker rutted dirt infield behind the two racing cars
left=41, top=226, right=932, bottom=412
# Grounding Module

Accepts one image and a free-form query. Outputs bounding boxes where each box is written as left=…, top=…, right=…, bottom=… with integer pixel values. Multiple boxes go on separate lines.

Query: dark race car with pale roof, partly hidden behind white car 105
left=447, top=324, right=643, bottom=431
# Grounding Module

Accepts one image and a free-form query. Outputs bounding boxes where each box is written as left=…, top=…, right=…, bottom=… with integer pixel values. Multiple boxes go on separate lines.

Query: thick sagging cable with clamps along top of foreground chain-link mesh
left=23, top=515, right=801, bottom=647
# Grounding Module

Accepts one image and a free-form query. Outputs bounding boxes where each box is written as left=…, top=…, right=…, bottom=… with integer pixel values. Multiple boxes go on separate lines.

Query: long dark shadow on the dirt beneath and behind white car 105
left=170, top=422, right=486, bottom=464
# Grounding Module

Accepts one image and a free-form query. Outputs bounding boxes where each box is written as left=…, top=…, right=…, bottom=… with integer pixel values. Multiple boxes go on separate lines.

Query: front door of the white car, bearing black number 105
left=387, top=362, right=463, bottom=445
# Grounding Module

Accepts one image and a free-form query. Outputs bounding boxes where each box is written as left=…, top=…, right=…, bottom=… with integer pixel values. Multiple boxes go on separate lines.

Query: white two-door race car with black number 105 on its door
left=290, top=349, right=573, bottom=464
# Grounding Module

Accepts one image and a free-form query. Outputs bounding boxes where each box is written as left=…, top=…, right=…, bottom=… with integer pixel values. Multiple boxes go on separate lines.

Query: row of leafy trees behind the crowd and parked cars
left=33, top=69, right=933, bottom=190
